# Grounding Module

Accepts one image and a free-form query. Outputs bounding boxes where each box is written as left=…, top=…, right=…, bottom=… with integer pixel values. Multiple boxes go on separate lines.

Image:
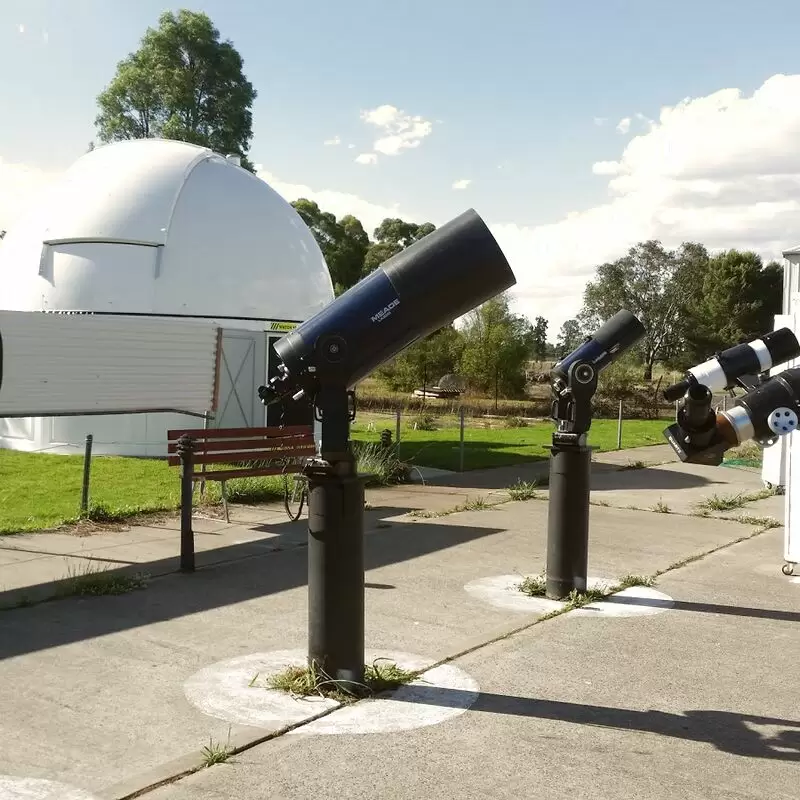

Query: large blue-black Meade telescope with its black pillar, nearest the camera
left=258, top=209, right=516, bottom=690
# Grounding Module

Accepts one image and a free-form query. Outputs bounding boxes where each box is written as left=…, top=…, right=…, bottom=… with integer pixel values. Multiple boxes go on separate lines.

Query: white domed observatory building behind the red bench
left=0, top=139, right=334, bottom=456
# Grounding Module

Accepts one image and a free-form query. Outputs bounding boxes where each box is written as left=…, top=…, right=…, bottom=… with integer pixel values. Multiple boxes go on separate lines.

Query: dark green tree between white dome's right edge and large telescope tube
left=292, top=198, right=369, bottom=295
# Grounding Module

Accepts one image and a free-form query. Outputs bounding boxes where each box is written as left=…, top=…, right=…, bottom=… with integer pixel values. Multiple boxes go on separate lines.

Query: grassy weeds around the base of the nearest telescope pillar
left=262, top=659, right=418, bottom=703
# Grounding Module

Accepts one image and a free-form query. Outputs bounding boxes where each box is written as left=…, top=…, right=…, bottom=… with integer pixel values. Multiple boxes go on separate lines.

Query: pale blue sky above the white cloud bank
left=0, top=0, right=800, bottom=330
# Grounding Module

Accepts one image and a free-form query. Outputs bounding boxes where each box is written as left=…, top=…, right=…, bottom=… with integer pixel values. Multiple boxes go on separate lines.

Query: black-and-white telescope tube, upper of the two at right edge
left=664, top=328, right=800, bottom=402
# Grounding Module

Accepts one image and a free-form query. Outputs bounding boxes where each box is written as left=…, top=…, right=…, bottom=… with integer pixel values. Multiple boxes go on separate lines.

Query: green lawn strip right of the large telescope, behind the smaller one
left=352, top=415, right=668, bottom=470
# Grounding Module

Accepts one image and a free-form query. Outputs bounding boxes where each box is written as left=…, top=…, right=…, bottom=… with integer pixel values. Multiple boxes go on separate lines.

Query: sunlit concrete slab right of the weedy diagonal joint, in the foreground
left=148, top=532, right=800, bottom=800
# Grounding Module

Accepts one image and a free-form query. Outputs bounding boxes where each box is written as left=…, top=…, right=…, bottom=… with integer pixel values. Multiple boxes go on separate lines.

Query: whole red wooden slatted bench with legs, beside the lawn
left=167, top=425, right=317, bottom=572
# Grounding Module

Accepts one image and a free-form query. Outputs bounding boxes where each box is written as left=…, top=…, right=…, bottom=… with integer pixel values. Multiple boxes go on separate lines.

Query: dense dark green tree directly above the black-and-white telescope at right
left=687, top=250, right=783, bottom=363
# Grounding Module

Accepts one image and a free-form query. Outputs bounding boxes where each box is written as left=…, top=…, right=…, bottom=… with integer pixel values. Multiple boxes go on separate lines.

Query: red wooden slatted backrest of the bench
left=167, top=425, right=317, bottom=466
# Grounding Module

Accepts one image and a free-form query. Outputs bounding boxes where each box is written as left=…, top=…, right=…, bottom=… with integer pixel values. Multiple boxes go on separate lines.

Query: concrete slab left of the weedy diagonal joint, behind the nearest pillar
left=0, top=501, right=777, bottom=796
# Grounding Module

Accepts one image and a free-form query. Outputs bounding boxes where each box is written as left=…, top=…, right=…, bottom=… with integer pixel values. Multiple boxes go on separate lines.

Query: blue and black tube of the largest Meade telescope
left=275, top=209, right=516, bottom=387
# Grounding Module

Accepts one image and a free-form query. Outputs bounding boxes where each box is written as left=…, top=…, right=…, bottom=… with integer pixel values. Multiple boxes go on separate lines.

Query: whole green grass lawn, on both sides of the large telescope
left=0, top=414, right=666, bottom=534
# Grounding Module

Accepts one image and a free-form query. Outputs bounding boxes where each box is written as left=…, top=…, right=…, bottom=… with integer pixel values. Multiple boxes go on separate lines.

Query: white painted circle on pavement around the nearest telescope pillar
left=184, top=650, right=480, bottom=736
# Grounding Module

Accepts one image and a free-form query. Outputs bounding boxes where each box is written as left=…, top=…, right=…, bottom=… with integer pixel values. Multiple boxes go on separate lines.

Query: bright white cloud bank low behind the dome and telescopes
left=7, top=75, right=800, bottom=336
